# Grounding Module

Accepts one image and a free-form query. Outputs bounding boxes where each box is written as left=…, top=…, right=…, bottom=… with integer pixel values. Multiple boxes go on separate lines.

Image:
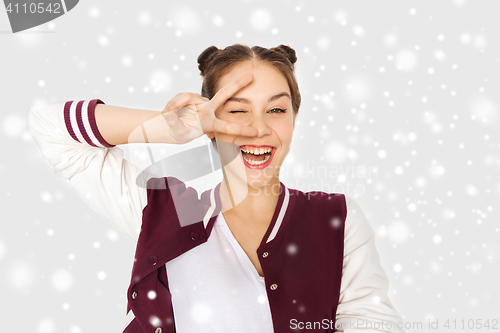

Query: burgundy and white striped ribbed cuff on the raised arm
left=64, top=99, right=115, bottom=148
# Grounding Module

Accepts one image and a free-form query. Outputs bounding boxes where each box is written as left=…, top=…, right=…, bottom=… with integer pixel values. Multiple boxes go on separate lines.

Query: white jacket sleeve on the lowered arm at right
left=335, top=195, right=405, bottom=333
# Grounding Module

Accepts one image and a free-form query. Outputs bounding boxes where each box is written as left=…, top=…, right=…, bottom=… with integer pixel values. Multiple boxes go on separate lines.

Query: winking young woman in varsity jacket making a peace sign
left=28, top=44, right=404, bottom=333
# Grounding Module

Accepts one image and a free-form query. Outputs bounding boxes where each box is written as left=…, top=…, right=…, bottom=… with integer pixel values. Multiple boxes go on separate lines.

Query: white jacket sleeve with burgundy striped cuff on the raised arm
left=27, top=99, right=147, bottom=241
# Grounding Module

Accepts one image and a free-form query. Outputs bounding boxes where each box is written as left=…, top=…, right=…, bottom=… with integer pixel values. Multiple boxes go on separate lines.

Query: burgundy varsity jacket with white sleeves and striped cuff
left=27, top=99, right=404, bottom=333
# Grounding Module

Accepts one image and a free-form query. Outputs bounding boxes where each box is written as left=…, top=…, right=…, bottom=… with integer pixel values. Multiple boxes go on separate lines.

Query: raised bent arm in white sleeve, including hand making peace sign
left=27, top=74, right=258, bottom=240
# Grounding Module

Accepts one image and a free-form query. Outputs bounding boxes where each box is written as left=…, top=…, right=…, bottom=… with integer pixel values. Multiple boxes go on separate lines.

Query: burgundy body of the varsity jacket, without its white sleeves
left=124, top=177, right=347, bottom=333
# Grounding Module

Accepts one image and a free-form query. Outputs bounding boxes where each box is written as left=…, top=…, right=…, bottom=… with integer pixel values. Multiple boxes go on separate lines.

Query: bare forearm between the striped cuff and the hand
left=95, top=104, right=171, bottom=145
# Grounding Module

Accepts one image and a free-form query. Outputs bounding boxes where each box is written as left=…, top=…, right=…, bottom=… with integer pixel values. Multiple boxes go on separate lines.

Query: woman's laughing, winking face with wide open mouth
left=215, top=61, right=295, bottom=187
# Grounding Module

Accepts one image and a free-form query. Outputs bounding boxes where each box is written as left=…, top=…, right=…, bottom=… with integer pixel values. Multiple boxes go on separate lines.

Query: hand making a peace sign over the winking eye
left=162, top=73, right=258, bottom=144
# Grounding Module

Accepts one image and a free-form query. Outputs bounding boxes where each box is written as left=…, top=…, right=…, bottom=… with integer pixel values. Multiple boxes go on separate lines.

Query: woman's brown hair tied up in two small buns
left=198, top=44, right=301, bottom=148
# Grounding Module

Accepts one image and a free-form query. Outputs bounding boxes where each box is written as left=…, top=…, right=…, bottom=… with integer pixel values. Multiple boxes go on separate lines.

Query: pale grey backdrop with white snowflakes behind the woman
left=0, top=0, right=500, bottom=333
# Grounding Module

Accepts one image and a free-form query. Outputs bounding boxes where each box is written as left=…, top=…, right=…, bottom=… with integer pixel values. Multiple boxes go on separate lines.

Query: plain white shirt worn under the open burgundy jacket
left=166, top=213, right=273, bottom=333
